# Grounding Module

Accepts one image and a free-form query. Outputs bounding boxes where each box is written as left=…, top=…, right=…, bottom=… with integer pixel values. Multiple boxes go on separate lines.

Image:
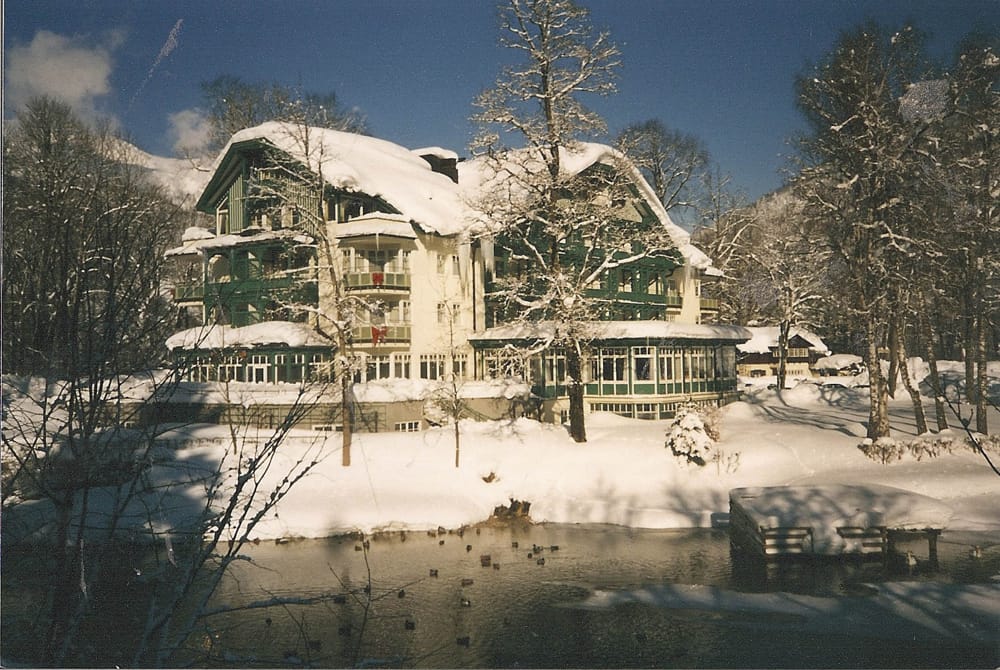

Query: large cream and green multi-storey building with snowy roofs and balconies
left=158, top=122, right=749, bottom=430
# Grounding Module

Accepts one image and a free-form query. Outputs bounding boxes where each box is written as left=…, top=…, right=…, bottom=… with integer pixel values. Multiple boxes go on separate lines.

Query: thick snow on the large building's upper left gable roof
left=212, top=121, right=466, bottom=235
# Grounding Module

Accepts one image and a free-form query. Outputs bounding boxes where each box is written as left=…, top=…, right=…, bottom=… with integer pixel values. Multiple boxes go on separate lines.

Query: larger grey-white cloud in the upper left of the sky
left=5, top=30, right=123, bottom=118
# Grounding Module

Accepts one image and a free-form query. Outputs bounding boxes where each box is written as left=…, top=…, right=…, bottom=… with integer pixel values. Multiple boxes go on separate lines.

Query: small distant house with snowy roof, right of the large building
left=736, top=326, right=830, bottom=378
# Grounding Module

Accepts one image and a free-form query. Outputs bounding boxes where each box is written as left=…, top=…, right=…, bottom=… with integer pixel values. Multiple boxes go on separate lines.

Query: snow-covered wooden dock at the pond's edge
left=729, top=484, right=952, bottom=564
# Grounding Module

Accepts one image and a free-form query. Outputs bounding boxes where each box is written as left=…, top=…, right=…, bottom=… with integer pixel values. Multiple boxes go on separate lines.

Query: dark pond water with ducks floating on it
left=198, top=525, right=1000, bottom=667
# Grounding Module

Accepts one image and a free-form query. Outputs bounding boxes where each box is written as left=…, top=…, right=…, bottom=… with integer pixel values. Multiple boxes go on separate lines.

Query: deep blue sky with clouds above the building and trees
left=4, top=0, right=1000, bottom=197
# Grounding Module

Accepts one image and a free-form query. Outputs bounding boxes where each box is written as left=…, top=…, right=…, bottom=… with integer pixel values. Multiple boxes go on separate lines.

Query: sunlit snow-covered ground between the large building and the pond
left=8, top=370, right=1000, bottom=543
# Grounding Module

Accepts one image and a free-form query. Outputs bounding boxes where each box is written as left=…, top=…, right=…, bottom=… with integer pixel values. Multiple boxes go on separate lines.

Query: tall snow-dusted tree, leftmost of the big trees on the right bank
left=797, top=25, right=923, bottom=439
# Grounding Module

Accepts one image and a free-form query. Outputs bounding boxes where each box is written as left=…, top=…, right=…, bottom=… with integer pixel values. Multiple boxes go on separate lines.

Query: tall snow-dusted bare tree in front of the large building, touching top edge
left=473, top=0, right=673, bottom=442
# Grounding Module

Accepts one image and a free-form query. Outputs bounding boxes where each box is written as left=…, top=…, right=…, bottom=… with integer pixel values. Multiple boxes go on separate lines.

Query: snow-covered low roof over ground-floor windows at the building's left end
left=166, top=321, right=331, bottom=350
